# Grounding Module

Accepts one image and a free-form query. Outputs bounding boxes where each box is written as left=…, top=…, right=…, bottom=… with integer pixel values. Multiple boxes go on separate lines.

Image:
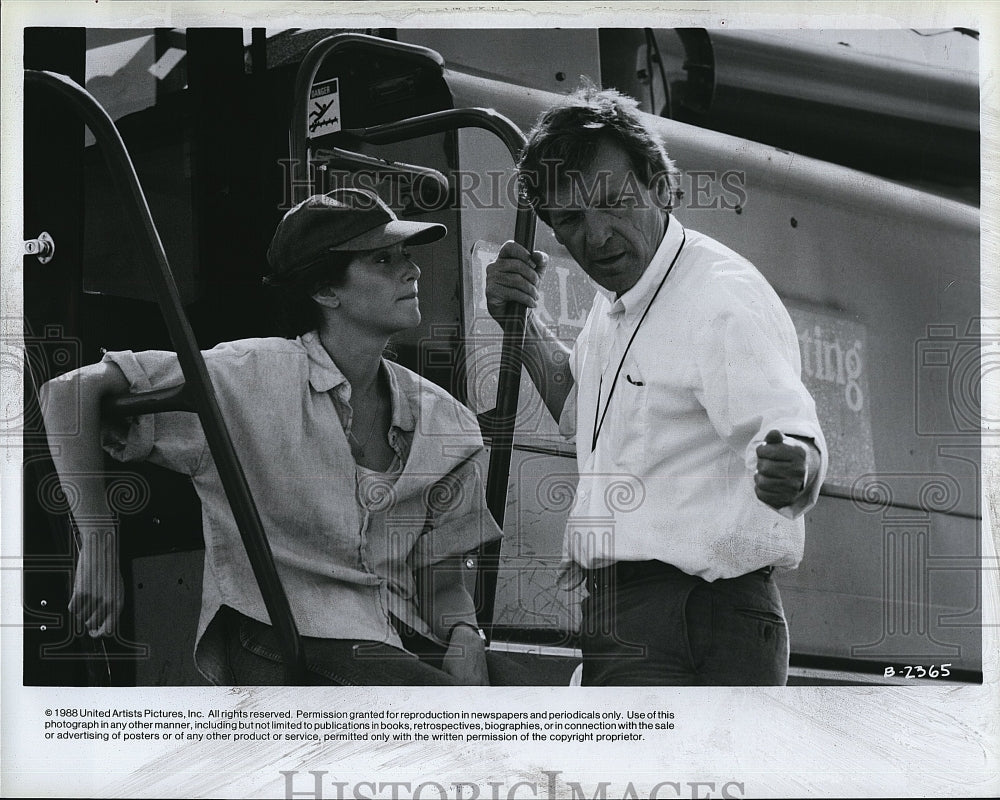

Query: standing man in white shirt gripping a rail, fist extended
left=486, top=89, right=827, bottom=685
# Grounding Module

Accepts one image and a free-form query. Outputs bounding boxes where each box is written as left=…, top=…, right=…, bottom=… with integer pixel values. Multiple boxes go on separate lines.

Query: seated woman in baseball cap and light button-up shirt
left=42, top=189, right=500, bottom=685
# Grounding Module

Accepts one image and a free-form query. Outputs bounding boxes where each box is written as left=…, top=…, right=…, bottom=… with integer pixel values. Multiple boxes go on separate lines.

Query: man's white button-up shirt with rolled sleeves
left=560, top=217, right=827, bottom=585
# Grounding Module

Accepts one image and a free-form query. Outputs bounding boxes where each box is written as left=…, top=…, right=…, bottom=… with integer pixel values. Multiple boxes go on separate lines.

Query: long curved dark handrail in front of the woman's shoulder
left=24, top=70, right=305, bottom=685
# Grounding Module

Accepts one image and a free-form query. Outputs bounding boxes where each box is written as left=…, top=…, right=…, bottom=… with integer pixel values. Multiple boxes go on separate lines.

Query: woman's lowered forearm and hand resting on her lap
left=417, top=556, right=490, bottom=686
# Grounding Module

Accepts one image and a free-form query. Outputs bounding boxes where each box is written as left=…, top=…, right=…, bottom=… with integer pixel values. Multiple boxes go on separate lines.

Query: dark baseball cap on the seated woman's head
left=264, top=189, right=448, bottom=285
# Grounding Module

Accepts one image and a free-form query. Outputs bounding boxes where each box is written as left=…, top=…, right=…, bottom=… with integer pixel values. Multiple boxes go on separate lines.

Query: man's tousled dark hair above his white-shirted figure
left=517, top=85, right=680, bottom=223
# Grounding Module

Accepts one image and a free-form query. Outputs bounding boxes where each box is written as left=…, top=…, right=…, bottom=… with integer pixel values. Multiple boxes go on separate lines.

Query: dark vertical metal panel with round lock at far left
left=22, top=28, right=91, bottom=685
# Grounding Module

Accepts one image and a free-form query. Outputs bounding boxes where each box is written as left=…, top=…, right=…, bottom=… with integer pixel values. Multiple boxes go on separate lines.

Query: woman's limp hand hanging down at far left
left=69, top=529, right=125, bottom=638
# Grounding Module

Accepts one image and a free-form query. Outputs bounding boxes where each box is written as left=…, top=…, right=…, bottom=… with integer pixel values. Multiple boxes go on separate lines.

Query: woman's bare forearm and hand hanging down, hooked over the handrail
left=39, top=363, right=129, bottom=637
